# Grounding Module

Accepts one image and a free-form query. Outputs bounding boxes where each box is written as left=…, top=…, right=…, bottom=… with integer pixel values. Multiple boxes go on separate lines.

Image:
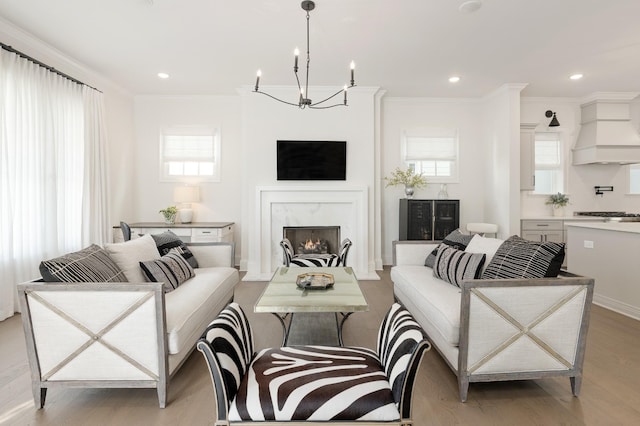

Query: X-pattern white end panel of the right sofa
left=458, top=273, right=594, bottom=400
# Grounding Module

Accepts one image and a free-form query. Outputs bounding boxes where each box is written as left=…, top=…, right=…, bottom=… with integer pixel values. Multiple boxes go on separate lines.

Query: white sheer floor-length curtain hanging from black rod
left=0, top=49, right=106, bottom=320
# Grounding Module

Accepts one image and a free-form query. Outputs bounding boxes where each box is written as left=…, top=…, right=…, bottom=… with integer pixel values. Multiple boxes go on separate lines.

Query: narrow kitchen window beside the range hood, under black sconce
left=534, top=132, right=564, bottom=194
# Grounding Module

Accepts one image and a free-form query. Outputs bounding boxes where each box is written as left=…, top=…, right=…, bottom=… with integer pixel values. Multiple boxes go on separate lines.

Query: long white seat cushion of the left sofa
left=165, top=266, right=239, bottom=354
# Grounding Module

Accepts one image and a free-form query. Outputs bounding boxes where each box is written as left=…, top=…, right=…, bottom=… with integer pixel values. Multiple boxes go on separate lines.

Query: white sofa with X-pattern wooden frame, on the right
left=391, top=240, right=594, bottom=402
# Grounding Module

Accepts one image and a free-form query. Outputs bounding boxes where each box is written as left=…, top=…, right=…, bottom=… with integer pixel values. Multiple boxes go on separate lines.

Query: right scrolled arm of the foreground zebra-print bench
left=376, top=303, right=431, bottom=418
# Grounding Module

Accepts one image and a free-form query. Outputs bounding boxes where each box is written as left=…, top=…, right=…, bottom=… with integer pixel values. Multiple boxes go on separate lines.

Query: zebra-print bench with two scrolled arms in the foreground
left=197, top=303, right=431, bottom=426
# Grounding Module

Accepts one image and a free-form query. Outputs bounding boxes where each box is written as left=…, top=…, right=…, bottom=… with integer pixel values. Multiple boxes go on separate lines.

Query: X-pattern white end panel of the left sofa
left=18, top=282, right=168, bottom=407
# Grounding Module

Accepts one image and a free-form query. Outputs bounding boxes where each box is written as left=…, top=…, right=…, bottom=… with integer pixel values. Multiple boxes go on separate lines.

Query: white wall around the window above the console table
left=134, top=96, right=244, bottom=253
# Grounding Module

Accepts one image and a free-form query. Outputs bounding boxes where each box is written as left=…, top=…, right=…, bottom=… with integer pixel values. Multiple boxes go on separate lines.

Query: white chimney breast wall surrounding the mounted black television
left=239, top=86, right=379, bottom=270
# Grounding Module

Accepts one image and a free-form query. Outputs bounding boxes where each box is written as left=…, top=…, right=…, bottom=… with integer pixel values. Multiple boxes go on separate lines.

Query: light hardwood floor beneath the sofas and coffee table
left=0, top=269, right=640, bottom=426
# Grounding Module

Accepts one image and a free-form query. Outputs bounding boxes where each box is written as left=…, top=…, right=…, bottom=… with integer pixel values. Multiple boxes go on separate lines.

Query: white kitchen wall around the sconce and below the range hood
left=521, top=98, right=640, bottom=217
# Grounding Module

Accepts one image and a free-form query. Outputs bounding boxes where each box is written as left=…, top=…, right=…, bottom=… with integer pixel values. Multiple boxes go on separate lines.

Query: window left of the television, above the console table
left=160, top=127, right=220, bottom=182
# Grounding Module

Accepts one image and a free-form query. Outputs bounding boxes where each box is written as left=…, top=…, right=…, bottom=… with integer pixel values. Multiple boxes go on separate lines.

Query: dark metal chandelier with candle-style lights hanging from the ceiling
left=253, top=1, right=356, bottom=109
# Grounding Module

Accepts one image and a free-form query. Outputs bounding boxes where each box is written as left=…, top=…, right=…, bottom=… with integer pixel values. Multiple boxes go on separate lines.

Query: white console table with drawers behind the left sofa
left=113, top=222, right=234, bottom=243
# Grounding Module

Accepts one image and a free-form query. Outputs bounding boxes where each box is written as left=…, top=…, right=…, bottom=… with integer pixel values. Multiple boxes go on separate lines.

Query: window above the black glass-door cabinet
left=402, top=128, right=458, bottom=183
